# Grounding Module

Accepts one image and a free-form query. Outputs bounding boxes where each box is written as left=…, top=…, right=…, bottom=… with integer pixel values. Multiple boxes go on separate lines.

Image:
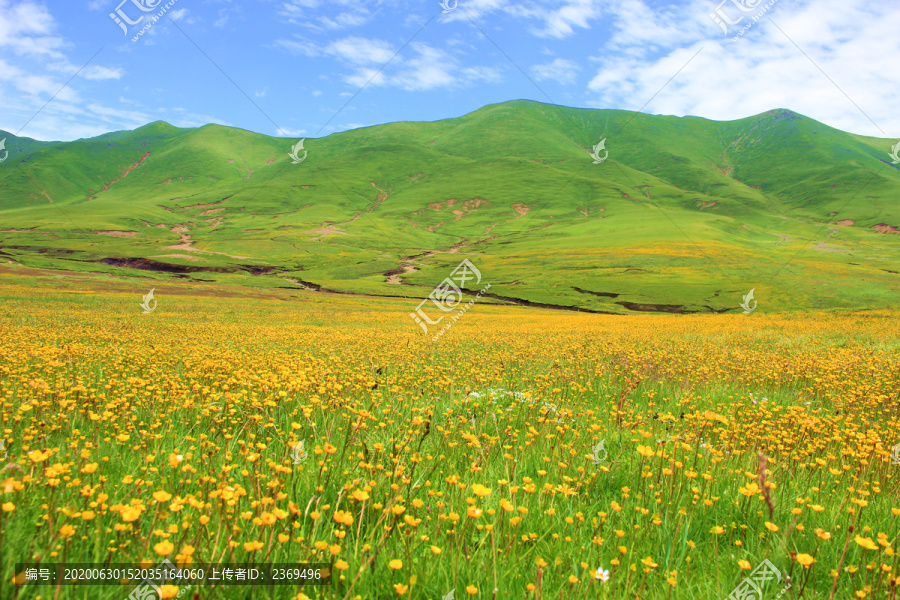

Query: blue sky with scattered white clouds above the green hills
left=0, top=0, right=900, bottom=140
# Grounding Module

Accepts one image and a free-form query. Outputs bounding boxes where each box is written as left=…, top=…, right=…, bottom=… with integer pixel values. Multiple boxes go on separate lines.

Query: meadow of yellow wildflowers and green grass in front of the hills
left=0, top=285, right=900, bottom=600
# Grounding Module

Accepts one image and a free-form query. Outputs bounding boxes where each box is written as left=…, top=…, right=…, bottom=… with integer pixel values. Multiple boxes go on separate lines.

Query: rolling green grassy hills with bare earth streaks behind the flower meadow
left=0, top=101, right=900, bottom=313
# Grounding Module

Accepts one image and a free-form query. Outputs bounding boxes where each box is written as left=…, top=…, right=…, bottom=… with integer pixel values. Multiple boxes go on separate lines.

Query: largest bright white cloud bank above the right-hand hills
left=588, top=0, right=900, bottom=136
